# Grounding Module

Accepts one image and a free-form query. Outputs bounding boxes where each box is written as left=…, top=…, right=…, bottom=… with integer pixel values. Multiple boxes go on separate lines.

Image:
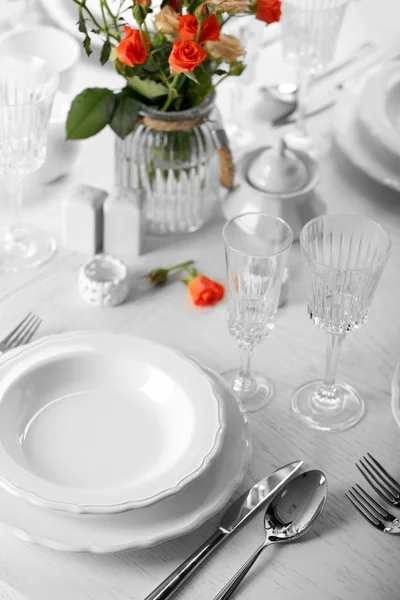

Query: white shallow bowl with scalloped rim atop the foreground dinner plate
left=0, top=332, right=225, bottom=513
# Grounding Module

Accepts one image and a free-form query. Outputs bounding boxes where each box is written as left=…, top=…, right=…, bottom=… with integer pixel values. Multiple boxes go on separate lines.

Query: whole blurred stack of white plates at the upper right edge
left=334, top=59, right=400, bottom=192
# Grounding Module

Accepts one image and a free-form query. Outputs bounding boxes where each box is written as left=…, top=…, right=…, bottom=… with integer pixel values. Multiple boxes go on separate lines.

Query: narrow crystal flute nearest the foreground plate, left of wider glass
left=223, top=213, right=293, bottom=412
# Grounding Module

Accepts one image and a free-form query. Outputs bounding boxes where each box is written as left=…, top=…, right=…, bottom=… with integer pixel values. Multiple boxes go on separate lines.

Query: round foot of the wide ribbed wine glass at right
left=291, top=381, right=364, bottom=431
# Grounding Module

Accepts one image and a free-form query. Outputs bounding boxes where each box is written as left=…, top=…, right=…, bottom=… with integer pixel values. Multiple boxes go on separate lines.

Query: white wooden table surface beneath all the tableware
left=0, top=0, right=400, bottom=600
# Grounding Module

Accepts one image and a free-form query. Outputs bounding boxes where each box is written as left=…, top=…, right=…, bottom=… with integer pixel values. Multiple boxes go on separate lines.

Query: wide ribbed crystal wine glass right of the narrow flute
left=292, top=214, right=391, bottom=431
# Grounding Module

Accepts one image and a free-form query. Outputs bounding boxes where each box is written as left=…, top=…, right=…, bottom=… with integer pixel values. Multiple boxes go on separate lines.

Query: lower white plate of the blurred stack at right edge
left=333, top=92, right=400, bottom=192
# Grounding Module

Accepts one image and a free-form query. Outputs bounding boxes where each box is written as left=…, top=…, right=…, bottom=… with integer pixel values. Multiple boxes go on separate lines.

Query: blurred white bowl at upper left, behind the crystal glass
left=0, top=25, right=81, bottom=92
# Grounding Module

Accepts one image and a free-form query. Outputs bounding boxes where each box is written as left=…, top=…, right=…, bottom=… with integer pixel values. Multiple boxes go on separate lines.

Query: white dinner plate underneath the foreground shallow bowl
left=0, top=360, right=251, bottom=553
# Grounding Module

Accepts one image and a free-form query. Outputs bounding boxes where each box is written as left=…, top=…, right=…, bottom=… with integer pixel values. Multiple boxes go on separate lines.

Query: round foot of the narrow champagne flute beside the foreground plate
left=222, top=369, right=274, bottom=412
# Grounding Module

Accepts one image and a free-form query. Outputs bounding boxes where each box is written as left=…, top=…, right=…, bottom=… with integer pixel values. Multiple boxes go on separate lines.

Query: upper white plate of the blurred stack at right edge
left=359, top=60, right=400, bottom=159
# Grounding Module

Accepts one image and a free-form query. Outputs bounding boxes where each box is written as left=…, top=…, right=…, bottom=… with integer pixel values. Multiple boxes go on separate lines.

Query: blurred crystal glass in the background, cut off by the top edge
left=281, top=0, right=349, bottom=150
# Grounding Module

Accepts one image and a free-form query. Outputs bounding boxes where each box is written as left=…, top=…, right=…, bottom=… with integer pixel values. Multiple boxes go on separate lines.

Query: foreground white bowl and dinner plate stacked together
left=0, top=332, right=251, bottom=553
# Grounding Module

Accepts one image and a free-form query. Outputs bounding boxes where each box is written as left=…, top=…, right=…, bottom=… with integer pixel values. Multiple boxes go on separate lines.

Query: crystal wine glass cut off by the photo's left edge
left=0, top=55, right=58, bottom=271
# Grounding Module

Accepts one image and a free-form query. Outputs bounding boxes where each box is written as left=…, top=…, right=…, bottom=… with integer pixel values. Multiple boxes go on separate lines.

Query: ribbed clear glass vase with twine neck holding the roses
left=116, top=95, right=220, bottom=234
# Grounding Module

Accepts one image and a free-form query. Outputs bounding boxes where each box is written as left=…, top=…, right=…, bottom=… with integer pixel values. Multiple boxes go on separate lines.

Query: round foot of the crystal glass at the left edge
left=0, top=225, right=56, bottom=271
